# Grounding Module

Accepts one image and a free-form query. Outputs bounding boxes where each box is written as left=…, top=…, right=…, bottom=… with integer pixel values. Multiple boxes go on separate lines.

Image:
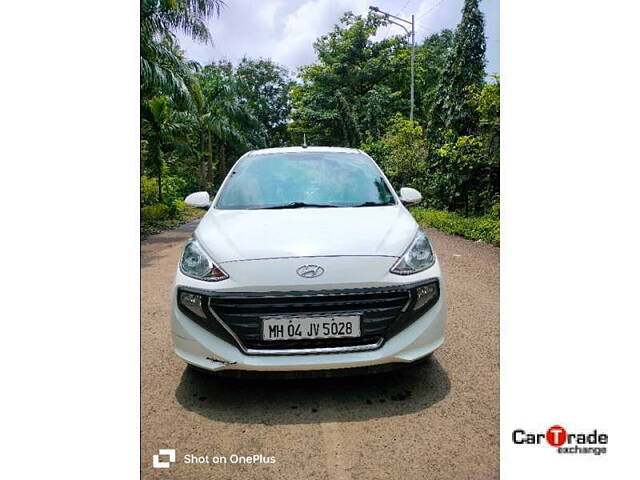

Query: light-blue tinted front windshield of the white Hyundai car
left=216, top=152, right=395, bottom=209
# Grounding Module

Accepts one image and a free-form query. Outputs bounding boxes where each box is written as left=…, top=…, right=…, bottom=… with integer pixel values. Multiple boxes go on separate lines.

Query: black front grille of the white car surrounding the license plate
left=180, top=279, right=439, bottom=355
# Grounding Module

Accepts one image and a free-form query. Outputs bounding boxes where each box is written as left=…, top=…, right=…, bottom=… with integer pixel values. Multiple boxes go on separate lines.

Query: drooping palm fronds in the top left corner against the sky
left=140, top=0, right=224, bottom=104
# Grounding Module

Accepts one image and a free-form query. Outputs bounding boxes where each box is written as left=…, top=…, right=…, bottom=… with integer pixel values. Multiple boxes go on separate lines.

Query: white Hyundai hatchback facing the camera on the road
left=171, top=147, right=446, bottom=373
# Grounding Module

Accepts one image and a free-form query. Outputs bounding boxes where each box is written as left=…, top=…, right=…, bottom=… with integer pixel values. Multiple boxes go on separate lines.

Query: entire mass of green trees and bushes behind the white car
left=140, top=0, right=500, bottom=240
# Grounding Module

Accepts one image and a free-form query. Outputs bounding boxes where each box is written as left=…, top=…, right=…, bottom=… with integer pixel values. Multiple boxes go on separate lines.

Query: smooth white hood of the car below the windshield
left=195, top=205, right=418, bottom=262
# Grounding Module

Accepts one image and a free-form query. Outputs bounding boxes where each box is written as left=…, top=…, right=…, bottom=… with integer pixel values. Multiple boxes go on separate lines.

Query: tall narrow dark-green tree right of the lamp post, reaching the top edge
left=429, top=0, right=486, bottom=139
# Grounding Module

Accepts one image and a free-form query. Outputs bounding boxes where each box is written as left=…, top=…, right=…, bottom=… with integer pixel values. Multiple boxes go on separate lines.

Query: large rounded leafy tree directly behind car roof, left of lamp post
left=290, top=12, right=408, bottom=147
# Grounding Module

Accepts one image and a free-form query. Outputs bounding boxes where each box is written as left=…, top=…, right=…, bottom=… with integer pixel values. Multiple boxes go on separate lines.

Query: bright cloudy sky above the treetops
left=180, top=0, right=500, bottom=74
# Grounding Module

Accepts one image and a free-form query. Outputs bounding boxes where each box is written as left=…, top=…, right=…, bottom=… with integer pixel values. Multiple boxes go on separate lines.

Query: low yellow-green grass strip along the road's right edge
left=411, top=207, right=500, bottom=247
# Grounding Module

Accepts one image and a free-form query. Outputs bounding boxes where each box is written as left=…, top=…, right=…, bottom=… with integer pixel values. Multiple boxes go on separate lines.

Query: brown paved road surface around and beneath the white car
left=141, top=224, right=500, bottom=480
